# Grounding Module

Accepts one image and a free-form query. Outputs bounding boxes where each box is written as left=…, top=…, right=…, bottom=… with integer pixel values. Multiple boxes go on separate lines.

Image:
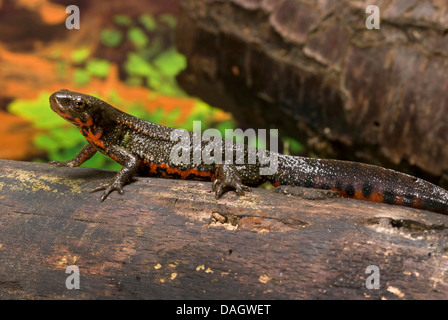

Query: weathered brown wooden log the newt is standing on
left=0, top=160, right=448, bottom=299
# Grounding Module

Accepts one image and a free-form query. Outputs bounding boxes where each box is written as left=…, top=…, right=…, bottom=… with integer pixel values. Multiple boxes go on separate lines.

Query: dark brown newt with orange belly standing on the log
left=50, top=89, right=448, bottom=214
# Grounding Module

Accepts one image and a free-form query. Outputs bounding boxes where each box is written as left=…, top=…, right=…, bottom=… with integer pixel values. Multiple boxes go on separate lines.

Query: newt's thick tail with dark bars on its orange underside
left=271, top=155, right=448, bottom=214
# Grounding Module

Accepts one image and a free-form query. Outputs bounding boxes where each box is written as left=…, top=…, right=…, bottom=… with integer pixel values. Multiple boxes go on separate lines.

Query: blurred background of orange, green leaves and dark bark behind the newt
left=0, top=0, right=448, bottom=187
